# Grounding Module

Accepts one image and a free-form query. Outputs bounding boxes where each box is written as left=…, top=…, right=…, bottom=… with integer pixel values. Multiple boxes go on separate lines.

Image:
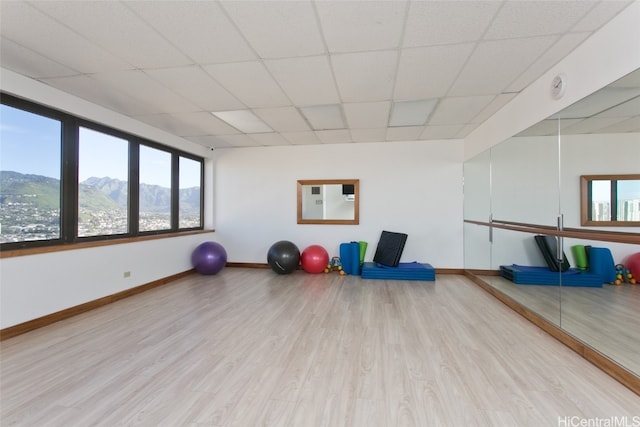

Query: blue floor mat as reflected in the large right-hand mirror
left=500, top=264, right=604, bottom=288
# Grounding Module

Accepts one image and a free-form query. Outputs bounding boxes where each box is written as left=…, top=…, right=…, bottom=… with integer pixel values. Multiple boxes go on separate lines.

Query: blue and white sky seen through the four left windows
left=0, top=105, right=200, bottom=188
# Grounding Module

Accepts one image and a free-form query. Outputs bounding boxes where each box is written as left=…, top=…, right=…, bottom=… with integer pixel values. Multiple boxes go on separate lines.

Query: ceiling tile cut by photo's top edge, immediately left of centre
left=221, top=1, right=325, bottom=59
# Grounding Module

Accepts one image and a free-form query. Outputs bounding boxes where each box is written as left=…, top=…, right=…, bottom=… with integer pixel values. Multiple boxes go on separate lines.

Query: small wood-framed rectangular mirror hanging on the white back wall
left=297, top=179, right=360, bottom=224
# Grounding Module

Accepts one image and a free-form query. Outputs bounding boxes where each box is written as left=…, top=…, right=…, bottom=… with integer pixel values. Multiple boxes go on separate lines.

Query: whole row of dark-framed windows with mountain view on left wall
left=0, top=94, right=204, bottom=249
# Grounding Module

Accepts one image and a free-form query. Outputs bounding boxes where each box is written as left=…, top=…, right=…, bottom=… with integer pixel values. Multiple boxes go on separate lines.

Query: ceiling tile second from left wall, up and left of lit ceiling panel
left=91, top=70, right=197, bottom=113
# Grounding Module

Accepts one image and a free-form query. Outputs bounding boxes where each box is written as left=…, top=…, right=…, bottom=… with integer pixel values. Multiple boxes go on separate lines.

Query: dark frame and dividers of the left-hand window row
left=0, top=92, right=205, bottom=252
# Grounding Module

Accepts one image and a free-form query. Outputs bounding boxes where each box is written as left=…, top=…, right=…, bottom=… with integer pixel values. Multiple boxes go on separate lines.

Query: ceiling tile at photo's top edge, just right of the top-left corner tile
left=33, top=1, right=191, bottom=68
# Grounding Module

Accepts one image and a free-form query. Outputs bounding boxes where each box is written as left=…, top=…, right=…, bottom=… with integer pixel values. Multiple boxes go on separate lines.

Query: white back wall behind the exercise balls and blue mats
left=215, top=140, right=463, bottom=268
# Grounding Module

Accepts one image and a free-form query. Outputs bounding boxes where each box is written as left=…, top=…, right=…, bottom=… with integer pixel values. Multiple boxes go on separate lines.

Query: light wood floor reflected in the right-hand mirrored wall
left=482, top=276, right=640, bottom=376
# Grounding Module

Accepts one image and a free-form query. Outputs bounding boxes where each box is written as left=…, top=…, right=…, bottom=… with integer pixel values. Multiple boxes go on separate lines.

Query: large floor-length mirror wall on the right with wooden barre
left=464, top=70, right=640, bottom=389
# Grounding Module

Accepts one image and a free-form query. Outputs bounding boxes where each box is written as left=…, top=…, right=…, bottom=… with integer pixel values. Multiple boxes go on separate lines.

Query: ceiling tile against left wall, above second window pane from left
left=42, top=75, right=156, bottom=116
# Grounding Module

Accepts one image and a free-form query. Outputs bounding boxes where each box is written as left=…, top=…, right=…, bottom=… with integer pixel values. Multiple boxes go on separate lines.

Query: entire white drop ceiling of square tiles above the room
left=0, top=0, right=637, bottom=148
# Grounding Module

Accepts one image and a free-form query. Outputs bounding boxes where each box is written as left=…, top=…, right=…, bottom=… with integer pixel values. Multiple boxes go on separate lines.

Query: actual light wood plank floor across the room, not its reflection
left=0, top=268, right=640, bottom=427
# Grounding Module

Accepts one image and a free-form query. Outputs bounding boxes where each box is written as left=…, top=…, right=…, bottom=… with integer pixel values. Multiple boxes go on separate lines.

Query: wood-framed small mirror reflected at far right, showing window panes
left=580, top=174, right=640, bottom=227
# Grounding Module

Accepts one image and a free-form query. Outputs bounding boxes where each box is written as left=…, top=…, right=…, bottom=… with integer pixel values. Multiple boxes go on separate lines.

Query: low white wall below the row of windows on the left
left=0, top=233, right=215, bottom=329
